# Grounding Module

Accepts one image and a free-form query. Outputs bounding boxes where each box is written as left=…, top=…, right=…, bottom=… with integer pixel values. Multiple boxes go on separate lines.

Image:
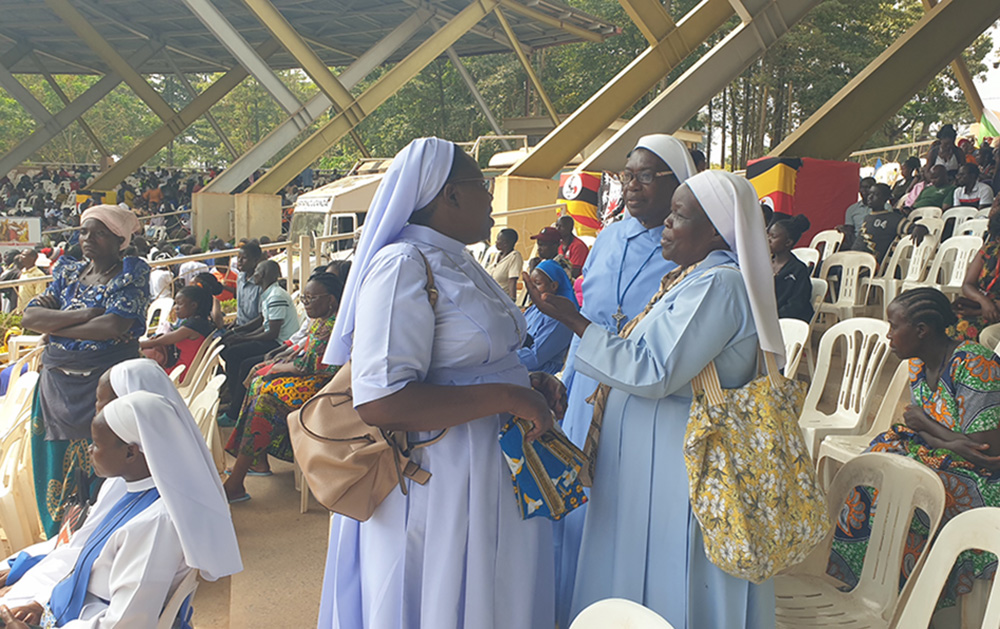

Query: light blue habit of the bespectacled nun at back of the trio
left=552, top=214, right=677, bottom=629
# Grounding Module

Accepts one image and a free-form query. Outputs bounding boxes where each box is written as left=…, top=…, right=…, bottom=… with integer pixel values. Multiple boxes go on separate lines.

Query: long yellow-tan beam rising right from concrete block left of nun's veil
left=247, top=0, right=499, bottom=194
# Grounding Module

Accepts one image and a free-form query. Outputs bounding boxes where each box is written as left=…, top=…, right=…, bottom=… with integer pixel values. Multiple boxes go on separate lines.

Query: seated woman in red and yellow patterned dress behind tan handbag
left=223, top=272, right=344, bottom=502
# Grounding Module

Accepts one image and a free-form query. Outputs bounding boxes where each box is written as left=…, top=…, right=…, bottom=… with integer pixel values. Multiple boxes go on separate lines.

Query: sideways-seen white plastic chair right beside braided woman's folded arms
left=816, top=360, right=910, bottom=487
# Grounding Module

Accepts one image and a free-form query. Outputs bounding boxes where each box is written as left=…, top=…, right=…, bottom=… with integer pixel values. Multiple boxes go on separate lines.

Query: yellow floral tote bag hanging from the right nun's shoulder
left=684, top=352, right=829, bottom=583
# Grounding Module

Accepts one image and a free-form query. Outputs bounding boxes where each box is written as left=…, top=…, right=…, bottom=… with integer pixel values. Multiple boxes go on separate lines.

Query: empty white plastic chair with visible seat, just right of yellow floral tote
left=774, top=453, right=947, bottom=629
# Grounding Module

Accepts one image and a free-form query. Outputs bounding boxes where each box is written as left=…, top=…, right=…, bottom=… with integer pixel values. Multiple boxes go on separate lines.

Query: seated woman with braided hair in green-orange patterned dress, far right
left=828, top=288, right=1000, bottom=607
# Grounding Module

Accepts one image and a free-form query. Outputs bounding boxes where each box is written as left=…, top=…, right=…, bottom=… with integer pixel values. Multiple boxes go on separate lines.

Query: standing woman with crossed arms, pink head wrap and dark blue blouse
left=23, top=205, right=149, bottom=536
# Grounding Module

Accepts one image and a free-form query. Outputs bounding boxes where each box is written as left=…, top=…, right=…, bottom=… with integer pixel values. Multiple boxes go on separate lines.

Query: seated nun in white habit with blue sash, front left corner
left=0, top=391, right=243, bottom=629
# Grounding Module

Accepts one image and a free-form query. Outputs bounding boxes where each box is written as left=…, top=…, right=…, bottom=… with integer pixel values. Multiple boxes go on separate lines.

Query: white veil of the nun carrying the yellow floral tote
left=685, top=170, right=785, bottom=365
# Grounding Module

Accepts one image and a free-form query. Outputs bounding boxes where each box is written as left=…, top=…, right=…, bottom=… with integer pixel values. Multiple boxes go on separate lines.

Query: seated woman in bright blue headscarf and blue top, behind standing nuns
left=517, top=260, right=576, bottom=375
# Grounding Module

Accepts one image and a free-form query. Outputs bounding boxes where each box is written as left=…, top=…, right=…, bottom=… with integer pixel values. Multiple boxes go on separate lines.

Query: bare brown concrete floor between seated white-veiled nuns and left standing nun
left=194, top=459, right=330, bottom=629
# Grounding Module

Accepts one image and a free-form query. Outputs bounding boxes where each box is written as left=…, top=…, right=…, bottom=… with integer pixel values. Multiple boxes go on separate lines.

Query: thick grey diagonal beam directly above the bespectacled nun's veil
left=579, top=0, right=821, bottom=170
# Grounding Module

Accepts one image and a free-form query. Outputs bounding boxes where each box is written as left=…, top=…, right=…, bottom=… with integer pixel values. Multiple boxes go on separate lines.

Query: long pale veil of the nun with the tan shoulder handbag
left=323, top=138, right=455, bottom=365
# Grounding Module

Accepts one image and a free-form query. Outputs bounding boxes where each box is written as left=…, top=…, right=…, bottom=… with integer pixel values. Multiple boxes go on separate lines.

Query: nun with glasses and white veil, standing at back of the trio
left=554, top=134, right=695, bottom=627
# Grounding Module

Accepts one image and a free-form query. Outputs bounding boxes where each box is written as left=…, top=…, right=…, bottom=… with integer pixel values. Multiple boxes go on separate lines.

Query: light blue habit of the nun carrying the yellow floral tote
left=572, top=251, right=775, bottom=629
